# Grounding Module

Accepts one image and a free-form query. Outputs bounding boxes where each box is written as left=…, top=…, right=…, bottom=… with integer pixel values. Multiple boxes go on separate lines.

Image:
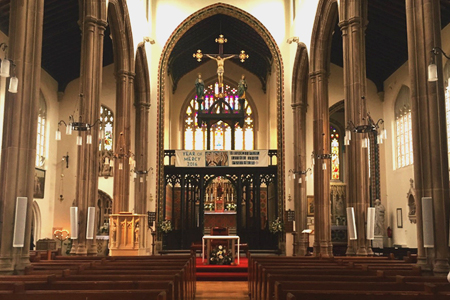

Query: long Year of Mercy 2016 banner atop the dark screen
left=175, top=150, right=269, bottom=167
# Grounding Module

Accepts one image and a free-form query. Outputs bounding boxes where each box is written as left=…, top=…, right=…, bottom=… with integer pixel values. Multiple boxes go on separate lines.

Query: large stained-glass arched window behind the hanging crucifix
left=184, top=83, right=255, bottom=150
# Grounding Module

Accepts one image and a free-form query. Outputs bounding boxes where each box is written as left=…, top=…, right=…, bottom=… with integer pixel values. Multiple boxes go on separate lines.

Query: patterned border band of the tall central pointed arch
left=156, top=3, right=284, bottom=225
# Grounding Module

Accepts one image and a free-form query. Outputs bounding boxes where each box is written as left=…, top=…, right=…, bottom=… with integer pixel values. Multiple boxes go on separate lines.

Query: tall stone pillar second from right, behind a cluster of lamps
left=339, top=0, right=373, bottom=255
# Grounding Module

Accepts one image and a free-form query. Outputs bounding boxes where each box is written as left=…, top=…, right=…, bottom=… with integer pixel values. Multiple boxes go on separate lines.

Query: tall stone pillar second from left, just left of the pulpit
left=75, top=0, right=107, bottom=255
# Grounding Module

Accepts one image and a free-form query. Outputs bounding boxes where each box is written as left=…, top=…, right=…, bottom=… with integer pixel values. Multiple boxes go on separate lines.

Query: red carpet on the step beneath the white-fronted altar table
left=196, top=257, right=248, bottom=281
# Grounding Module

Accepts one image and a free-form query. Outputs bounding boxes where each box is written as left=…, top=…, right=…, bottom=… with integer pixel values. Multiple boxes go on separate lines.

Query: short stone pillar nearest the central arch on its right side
left=292, top=103, right=309, bottom=256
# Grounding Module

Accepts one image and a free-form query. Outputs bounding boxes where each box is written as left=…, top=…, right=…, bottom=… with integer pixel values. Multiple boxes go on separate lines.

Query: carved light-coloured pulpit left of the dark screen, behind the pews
left=109, top=213, right=150, bottom=256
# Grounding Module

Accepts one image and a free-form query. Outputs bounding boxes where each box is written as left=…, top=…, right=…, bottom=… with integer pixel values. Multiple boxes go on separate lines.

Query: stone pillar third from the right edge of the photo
left=310, top=70, right=333, bottom=257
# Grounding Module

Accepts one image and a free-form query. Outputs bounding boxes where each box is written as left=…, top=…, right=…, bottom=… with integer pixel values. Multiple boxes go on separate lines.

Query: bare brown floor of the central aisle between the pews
left=195, top=281, right=249, bottom=300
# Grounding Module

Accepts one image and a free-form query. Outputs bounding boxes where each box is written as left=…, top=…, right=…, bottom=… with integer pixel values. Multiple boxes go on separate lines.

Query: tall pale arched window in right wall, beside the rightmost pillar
left=395, top=86, right=413, bottom=168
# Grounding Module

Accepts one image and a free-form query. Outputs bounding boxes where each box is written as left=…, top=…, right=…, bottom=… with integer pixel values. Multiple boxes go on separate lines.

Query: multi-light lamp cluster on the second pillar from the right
left=344, top=96, right=387, bottom=148
